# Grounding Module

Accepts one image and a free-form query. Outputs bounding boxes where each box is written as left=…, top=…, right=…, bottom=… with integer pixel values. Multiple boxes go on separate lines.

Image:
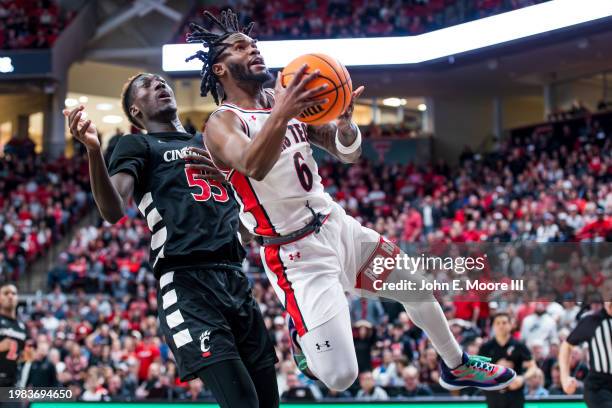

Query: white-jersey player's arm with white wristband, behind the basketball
left=308, top=86, right=365, bottom=163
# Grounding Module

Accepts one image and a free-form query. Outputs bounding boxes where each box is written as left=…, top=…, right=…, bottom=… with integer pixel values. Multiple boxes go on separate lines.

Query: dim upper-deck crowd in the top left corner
left=0, top=0, right=73, bottom=50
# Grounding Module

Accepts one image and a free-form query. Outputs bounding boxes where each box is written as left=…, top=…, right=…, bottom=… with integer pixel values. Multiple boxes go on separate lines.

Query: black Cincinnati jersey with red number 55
left=109, top=132, right=244, bottom=278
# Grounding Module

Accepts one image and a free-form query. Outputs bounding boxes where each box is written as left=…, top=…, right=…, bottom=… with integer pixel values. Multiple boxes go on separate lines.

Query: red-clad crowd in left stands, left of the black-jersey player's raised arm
left=0, top=138, right=92, bottom=282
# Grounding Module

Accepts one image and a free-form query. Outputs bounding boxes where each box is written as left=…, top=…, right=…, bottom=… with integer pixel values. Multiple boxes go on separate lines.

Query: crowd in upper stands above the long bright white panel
left=177, top=0, right=546, bottom=42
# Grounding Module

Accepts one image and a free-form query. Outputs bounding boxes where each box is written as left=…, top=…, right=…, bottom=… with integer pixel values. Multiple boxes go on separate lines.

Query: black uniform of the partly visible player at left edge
left=0, top=316, right=27, bottom=387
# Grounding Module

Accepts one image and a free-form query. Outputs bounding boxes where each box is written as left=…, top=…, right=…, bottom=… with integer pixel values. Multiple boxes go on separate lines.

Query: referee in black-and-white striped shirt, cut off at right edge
left=559, top=279, right=612, bottom=408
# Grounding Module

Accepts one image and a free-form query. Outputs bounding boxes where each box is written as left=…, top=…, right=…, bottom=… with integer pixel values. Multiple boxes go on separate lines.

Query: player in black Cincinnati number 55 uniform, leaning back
left=64, top=74, right=279, bottom=408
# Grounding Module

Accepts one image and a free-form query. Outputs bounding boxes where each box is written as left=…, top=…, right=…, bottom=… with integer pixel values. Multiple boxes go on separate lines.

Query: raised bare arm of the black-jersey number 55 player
left=63, top=106, right=134, bottom=224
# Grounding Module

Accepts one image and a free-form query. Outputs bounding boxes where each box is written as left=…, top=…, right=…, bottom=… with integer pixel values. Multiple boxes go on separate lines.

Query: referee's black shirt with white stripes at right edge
left=567, top=309, right=612, bottom=389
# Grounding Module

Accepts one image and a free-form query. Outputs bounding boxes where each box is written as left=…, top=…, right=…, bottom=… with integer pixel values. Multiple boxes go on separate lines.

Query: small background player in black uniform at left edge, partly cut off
left=0, top=283, right=26, bottom=387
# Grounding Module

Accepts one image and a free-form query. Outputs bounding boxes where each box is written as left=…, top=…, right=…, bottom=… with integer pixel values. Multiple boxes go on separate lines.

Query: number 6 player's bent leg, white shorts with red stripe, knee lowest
left=261, top=228, right=358, bottom=390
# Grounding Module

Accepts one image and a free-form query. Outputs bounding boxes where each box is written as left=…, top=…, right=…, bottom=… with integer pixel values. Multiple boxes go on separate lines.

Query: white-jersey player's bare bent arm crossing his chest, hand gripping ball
left=206, top=65, right=327, bottom=180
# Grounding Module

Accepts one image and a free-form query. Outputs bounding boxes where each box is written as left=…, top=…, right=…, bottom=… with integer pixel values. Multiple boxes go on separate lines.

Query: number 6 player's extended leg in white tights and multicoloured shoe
left=334, top=204, right=516, bottom=390
